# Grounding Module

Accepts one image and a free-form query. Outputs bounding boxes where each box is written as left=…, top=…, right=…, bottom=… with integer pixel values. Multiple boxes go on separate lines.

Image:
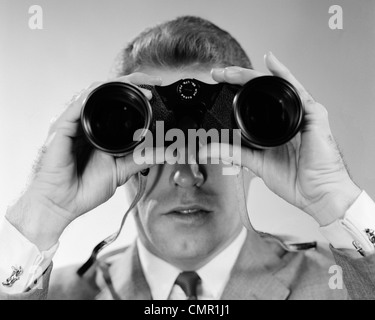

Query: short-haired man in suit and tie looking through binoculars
left=0, top=17, right=375, bottom=299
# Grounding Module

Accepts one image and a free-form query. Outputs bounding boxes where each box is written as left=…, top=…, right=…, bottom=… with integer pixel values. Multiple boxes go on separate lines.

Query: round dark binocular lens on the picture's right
left=234, top=76, right=303, bottom=148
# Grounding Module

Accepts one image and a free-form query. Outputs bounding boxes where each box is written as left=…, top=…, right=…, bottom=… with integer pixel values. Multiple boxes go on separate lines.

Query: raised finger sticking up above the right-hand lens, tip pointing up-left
left=264, top=52, right=314, bottom=102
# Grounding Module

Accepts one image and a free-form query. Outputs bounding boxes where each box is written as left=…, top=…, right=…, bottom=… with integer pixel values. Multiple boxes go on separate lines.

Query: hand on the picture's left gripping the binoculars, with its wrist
left=6, top=73, right=161, bottom=251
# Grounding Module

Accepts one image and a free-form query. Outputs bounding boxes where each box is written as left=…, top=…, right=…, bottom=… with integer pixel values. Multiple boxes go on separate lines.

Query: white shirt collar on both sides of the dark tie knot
left=137, top=229, right=246, bottom=300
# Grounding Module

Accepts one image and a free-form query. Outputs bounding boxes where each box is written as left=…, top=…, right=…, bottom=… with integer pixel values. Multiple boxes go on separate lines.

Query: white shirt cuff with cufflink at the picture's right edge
left=319, top=191, right=375, bottom=254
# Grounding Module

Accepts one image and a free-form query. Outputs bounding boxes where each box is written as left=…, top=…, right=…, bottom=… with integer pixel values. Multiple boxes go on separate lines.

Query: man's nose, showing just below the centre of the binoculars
left=172, top=163, right=205, bottom=188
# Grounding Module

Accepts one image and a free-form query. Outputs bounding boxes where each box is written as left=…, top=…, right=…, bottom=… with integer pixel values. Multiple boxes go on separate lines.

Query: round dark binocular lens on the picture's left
left=81, top=82, right=152, bottom=155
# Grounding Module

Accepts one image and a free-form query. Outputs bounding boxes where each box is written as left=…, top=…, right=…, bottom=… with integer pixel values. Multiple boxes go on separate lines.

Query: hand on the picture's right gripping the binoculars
left=207, top=53, right=361, bottom=226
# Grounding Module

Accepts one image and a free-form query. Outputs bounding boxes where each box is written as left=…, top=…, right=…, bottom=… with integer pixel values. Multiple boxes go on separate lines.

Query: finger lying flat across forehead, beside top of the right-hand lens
left=211, top=67, right=265, bottom=85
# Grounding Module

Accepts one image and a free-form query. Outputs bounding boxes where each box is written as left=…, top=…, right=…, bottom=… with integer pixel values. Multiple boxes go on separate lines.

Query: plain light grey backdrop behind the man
left=0, top=0, right=375, bottom=266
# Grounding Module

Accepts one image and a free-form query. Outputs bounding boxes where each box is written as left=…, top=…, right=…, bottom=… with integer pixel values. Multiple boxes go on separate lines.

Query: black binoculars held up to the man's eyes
left=81, top=76, right=304, bottom=156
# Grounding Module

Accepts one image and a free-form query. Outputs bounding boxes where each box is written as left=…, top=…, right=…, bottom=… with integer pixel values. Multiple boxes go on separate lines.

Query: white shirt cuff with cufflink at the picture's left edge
left=0, top=217, right=59, bottom=294
